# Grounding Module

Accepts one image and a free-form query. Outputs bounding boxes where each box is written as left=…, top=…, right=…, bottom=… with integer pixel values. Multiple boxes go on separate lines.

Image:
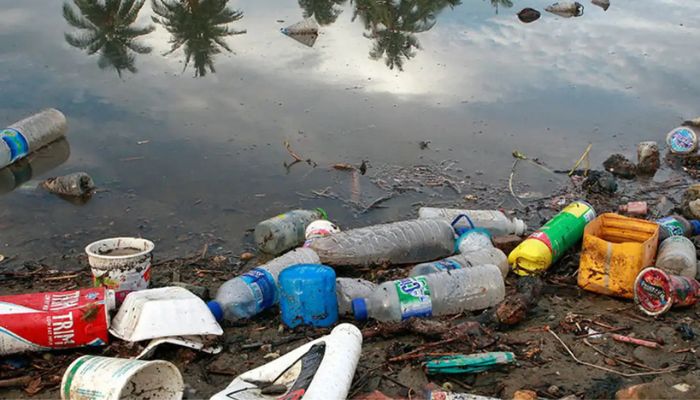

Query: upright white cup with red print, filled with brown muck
left=85, top=237, right=155, bottom=303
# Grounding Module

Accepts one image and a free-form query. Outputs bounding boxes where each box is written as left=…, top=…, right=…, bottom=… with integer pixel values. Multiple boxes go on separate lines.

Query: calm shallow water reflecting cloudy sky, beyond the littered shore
left=0, top=0, right=700, bottom=260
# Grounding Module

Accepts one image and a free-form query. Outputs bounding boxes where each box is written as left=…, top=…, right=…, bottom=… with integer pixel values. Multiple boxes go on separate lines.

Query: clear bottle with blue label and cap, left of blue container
left=207, top=248, right=319, bottom=321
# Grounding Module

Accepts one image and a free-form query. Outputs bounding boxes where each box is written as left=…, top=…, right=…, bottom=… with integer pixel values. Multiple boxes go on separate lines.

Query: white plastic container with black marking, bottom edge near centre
left=210, top=324, right=362, bottom=400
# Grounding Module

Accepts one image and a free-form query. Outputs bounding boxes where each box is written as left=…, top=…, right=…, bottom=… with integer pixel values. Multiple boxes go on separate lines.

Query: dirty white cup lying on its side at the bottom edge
left=61, top=356, right=184, bottom=400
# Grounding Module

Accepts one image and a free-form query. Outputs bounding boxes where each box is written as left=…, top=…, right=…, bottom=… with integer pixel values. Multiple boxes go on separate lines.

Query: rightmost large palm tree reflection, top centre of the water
left=353, top=0, right=462, bottom=71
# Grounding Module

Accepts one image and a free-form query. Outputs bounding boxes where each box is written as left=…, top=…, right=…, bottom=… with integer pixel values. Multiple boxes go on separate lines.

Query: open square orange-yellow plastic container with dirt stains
left=578, top=213, right=659, bottom=299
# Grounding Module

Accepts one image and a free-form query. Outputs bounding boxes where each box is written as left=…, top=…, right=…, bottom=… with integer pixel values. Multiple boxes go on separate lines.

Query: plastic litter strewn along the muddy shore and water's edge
left=0, top=110, right=700, bottom=400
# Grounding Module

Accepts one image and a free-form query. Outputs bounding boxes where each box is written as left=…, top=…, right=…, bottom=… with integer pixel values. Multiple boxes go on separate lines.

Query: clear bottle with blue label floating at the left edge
left=0, top=108, right=68, bottom=168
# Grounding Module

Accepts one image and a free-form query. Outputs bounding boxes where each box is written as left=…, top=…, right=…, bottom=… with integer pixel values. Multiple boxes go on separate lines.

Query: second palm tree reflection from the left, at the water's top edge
left=151, top=0, right=245, bottom=77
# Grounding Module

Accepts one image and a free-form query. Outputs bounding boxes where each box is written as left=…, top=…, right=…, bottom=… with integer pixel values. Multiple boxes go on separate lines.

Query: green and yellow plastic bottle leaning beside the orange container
left=508, top=200, right=595, bottom=275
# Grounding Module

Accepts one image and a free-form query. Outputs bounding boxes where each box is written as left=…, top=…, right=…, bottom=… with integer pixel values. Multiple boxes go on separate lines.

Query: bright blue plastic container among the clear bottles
left=279, top=264, right=338, bottom=328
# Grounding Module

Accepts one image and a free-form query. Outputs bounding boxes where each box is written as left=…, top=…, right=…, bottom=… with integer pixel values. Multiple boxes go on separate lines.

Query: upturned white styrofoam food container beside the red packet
left=109, top=286, right=224, bottom=342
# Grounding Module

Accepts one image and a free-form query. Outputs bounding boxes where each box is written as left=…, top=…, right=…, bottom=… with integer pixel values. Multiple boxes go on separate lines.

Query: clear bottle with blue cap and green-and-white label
left=352, top=265, right=505, bottom=322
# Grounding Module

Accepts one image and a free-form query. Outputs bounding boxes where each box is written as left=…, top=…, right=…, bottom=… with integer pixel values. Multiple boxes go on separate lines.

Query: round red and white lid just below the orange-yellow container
left=634, top=267, right=673, bottom=316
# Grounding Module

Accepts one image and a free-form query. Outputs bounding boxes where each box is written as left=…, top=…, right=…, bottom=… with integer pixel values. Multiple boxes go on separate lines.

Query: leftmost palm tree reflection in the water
left=63, top=0, right=155, bottom=77
